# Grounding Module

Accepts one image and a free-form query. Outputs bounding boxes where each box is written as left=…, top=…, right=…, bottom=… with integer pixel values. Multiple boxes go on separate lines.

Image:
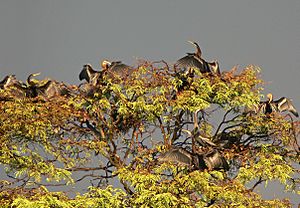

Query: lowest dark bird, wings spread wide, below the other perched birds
left=158, top=147, right=229, bottom=170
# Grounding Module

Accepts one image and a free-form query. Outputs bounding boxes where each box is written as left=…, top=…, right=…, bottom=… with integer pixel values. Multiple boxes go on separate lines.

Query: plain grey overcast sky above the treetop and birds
left=0, top=0, right=300, bottom=206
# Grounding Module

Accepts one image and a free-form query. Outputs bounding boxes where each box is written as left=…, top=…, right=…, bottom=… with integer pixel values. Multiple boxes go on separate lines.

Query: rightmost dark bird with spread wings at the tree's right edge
left=256, top=93, right=299, bottom=117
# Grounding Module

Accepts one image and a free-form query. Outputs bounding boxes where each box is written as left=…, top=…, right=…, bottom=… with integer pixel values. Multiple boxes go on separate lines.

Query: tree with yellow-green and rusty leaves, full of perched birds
left=0, top=62, right=300, bottom=207
